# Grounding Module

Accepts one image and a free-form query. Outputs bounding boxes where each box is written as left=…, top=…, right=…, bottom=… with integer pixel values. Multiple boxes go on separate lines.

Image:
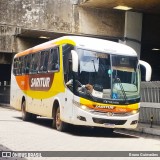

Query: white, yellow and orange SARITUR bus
left=10, top=36, right=151, bottom=131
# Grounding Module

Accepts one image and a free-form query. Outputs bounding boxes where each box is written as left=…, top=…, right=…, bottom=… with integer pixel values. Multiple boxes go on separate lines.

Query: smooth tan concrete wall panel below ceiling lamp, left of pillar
left=79, top=7, right=125, bottom=39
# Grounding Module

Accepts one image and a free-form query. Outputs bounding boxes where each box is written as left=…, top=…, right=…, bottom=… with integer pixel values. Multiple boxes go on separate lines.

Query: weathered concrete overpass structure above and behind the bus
left=0, top=0, right=160, bottom=53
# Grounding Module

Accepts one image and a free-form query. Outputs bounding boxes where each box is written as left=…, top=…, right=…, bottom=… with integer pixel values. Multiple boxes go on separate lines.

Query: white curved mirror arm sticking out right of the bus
left=139, top=60, right=152, bottom=82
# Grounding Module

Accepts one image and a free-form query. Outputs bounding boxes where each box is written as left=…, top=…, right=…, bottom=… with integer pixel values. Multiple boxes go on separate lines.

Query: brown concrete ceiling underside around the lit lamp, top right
left=80, top=0, right=160, bottom=14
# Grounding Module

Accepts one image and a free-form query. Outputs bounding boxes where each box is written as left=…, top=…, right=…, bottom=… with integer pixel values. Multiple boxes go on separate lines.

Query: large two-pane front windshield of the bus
left=74, top=49, right=140, bottom=101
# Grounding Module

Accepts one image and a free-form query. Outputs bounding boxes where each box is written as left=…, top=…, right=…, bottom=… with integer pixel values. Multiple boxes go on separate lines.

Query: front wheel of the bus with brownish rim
left=53, top=107, right=68, bottom=132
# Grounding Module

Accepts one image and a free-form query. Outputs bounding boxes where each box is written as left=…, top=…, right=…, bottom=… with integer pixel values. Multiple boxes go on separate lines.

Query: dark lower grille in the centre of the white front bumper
left=92, top=118, right=126, bottom=125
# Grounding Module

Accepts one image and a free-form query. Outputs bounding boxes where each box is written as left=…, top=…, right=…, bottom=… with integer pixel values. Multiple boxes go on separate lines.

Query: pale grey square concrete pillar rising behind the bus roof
left=120, top=11, right=143, bottom=57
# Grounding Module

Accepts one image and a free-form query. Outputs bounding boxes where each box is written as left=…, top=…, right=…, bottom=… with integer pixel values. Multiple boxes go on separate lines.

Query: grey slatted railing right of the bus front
left=139, top=81, right=160, bottom=124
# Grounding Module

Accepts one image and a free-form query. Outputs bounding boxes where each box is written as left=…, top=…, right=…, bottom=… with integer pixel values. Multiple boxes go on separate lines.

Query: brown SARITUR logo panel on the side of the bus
left=29, top=74, right=53, bottom=91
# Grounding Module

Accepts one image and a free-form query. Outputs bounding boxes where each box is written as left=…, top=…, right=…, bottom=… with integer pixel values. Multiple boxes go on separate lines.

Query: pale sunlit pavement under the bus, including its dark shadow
left=0, top=107, right=160, bottom=160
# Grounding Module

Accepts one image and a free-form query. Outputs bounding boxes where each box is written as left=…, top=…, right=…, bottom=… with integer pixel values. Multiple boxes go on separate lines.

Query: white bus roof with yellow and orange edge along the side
left=15, top=36, right=137, bottom=57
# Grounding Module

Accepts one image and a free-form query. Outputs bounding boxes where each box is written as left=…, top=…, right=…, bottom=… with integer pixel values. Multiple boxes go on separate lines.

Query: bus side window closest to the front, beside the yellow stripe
left=48, top=47, right=60, bottom=71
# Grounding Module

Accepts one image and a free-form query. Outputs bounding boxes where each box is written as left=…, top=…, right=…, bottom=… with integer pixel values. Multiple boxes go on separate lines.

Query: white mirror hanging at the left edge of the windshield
left=71, top=50, right=78, bottom=72
